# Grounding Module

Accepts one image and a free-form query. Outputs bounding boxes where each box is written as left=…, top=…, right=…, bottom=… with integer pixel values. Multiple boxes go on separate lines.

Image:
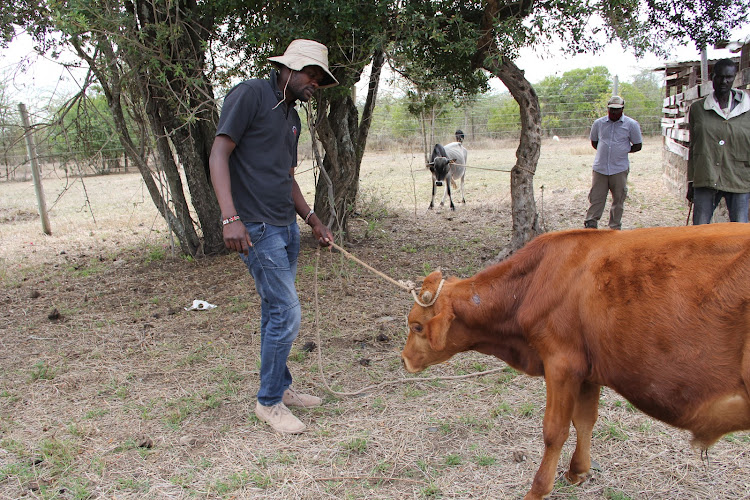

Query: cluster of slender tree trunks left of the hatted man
left=132, top=1, right=225, bottom=256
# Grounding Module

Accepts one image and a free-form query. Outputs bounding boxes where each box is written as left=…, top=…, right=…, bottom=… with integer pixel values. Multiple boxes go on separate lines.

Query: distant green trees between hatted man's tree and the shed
left=370, top=66, right=663, bottom=147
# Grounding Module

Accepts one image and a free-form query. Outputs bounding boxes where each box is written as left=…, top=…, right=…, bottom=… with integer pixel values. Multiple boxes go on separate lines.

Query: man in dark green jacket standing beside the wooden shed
left=687, top=59, right=750, bottom=225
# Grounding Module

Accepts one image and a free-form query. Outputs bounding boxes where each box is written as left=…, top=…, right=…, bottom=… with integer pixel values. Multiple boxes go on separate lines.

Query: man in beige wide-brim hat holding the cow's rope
left=209, top=40, right=338, bottom=434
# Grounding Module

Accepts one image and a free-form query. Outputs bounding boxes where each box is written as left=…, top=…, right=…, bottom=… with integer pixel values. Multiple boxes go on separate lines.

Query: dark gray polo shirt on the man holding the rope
left=216, top=70, right=301, bottom=226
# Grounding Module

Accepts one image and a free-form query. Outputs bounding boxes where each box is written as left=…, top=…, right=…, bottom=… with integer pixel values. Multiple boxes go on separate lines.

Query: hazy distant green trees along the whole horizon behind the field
left=0, top=66, right=663, bottom=179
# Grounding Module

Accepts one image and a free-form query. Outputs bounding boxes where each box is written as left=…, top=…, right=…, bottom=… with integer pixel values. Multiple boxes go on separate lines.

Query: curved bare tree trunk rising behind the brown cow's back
left=484, top=51, right=542, bottom=260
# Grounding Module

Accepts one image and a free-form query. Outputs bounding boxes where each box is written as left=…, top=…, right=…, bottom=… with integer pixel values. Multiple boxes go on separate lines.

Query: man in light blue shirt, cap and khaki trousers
left=583, top=95, right=643, bottom=229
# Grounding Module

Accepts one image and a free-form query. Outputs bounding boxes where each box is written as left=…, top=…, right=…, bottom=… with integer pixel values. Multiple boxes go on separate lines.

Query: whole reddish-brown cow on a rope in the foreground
left=402, top=223, right=750, bottom=499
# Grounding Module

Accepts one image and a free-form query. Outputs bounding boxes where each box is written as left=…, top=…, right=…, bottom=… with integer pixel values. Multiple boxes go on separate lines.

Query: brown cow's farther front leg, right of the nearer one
left=565, top=382, right=599, bottom=484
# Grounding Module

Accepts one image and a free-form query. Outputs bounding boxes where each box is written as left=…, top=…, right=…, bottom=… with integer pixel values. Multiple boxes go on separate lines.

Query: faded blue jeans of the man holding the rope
left=240, top=222, right=302, bottom=406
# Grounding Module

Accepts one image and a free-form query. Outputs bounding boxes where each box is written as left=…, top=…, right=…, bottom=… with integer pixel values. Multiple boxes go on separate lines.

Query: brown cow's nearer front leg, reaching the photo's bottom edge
left=524, top=365, right=580, bottom=500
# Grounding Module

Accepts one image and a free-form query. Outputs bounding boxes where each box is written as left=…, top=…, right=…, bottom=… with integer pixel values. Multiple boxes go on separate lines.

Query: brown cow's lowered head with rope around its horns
left=401, top=271, right=467, bottom=373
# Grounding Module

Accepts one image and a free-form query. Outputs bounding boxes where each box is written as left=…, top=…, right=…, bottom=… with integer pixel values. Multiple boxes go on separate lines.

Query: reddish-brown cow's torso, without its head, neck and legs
left=519, top=224, right=750, bottom=440
